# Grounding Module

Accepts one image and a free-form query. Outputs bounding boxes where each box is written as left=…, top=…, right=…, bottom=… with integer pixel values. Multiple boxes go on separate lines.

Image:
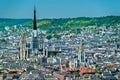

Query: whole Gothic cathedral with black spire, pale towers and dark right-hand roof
left=19, top=7, right=61, bottom=60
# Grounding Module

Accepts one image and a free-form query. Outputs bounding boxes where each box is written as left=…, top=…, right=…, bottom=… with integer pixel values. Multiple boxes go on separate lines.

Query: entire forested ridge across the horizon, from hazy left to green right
left=0, top=16, right=120, bottom=31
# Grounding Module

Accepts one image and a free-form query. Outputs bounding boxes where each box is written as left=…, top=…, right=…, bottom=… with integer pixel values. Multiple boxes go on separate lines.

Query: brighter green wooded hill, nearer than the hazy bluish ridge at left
left=23, top=16, right=120, bottom=33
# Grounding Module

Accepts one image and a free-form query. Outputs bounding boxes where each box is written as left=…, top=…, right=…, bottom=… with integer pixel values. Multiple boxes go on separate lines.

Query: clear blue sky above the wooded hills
left=0, top=0, right=120, bottom=19
